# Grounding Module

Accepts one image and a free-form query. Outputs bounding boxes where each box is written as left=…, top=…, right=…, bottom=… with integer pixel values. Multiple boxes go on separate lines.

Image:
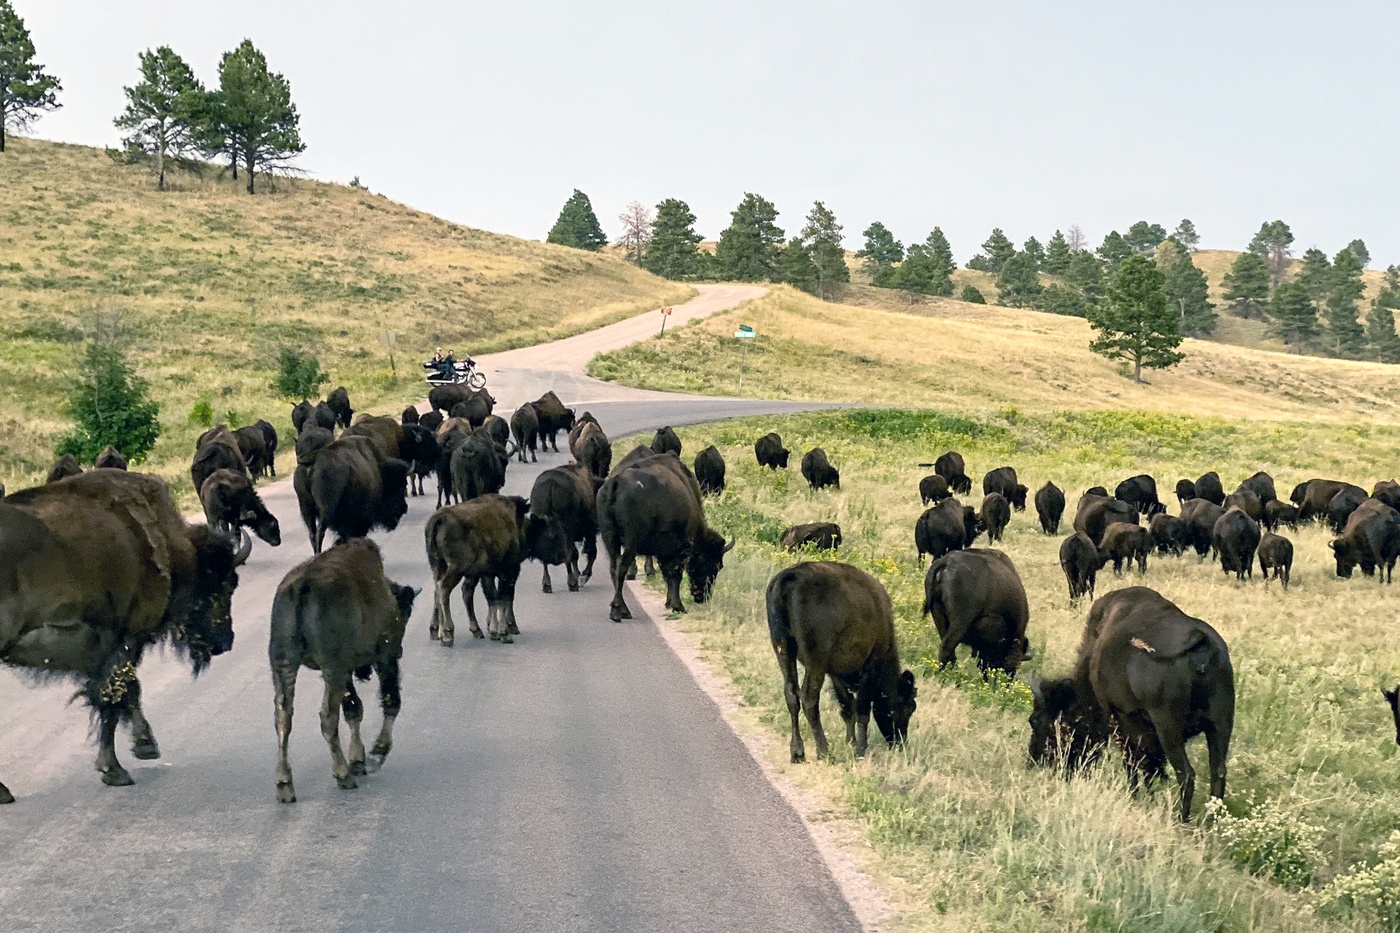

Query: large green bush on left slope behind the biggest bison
left=57, top=342, right=161, bottom=464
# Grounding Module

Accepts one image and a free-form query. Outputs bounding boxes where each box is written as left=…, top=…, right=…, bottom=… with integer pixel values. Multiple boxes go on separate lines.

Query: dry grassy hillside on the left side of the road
left=0, top=139, right=692, bottom=489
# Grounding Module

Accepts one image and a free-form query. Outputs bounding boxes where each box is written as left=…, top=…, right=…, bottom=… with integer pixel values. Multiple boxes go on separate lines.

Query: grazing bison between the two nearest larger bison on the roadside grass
left=924, top=548, right=1030, bottom=677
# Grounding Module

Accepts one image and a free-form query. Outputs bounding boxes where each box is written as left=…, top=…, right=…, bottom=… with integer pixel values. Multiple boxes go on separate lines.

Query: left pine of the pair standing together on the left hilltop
left=112, top=45, right=207, bottom=191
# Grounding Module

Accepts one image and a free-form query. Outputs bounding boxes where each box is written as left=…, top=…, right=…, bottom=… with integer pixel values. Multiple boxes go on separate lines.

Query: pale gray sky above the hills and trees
left=14, top=0, right=1400, bottom=266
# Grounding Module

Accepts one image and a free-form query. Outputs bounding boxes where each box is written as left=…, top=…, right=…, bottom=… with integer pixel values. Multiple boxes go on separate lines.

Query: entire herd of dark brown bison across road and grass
left=8, top=385, right=1400, bottom=820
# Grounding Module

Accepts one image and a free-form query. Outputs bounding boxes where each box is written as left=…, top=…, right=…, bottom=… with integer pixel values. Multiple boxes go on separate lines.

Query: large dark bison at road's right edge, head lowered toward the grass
left=598, top=448, right=735, bottom=622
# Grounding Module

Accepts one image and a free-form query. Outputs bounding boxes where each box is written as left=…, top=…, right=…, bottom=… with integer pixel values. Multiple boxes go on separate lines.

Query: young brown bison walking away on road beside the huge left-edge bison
left=267, top=538, right=419, bottom=803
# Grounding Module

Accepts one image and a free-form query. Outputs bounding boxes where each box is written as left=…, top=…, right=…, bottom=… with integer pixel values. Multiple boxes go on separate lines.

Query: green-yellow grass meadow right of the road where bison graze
left=649, top=410, right=1400, bottom=932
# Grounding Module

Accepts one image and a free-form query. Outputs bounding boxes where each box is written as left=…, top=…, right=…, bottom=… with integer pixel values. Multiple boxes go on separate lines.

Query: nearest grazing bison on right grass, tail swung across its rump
left=1030, top=587, right=1235, bottom=821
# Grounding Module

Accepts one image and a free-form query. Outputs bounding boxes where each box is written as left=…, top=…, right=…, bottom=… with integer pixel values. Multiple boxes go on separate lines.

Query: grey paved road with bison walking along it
left=0, top=287, right=860, bottom=933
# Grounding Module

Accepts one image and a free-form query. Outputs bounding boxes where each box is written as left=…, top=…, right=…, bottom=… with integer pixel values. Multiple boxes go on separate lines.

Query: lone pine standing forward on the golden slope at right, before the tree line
left=1089, top=255, right=1183, bottom=382
